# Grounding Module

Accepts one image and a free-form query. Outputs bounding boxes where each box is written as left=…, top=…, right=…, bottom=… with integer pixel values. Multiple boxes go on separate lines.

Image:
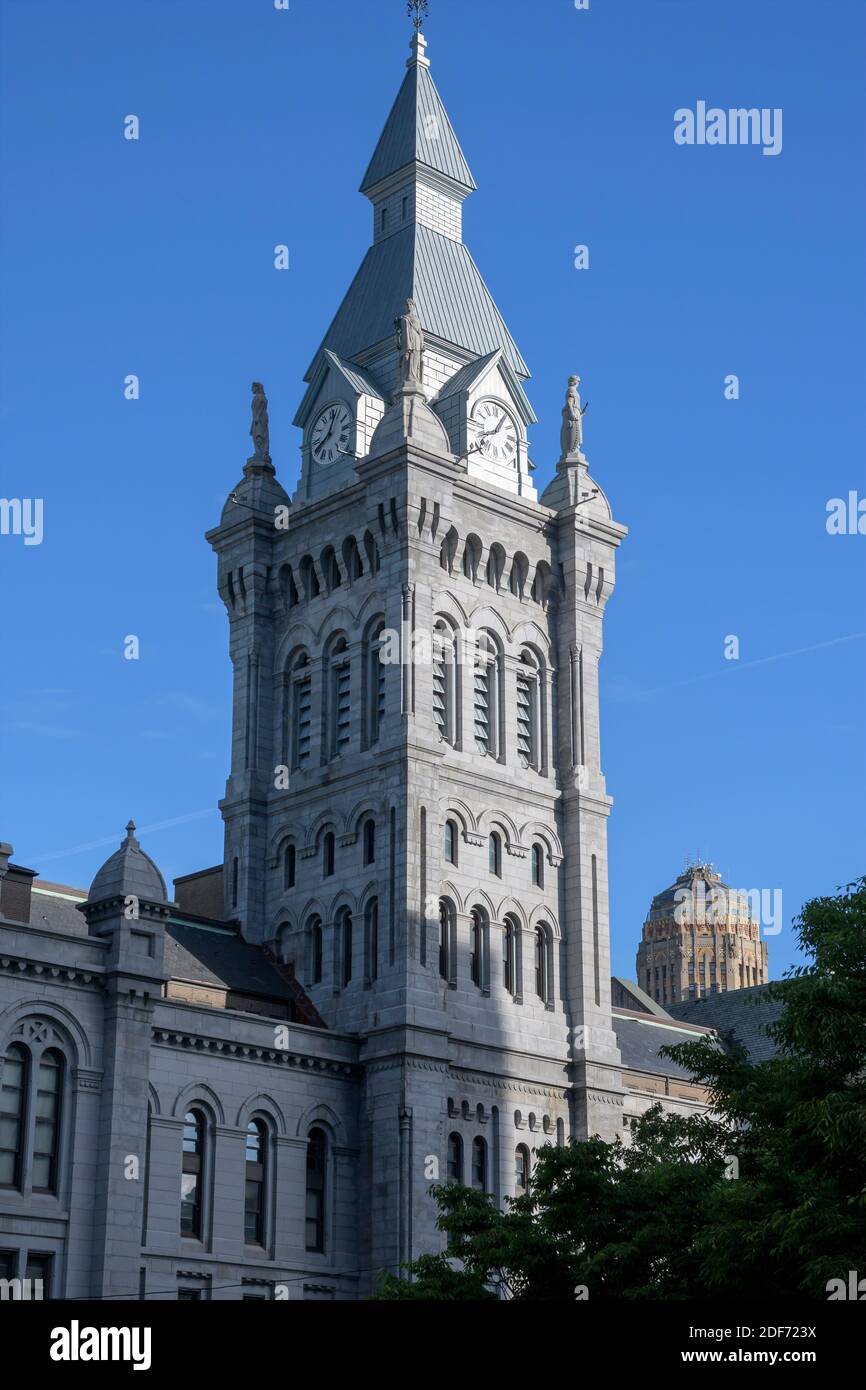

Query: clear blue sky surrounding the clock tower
left=0, top=0, right=866, bottom=976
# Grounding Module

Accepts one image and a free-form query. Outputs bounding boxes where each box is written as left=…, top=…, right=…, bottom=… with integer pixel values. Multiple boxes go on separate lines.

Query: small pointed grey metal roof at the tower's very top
left=361, top=61, right=475, bottom=193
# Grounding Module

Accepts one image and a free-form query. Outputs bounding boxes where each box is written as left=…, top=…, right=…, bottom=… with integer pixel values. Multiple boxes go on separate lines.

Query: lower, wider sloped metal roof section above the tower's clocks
left=304, top=224, right=530, bottom=381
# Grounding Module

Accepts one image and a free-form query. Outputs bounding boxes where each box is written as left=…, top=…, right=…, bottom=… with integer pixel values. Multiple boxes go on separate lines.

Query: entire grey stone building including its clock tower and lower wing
left=0, top=24, right=706, bottom=1300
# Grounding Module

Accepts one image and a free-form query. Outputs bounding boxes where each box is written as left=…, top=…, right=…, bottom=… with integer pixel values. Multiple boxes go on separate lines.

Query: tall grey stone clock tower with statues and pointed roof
left=209, top=24, right=626, bottom=1269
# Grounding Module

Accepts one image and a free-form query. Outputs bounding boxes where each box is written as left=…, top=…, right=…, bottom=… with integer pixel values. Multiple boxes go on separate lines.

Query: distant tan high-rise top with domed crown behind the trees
left=637, top=865, right=767, bottom=1004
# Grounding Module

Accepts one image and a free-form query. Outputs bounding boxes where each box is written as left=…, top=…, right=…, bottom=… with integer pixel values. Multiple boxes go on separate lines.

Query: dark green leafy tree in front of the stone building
left=375, top=878, right=866, bottom=1301
